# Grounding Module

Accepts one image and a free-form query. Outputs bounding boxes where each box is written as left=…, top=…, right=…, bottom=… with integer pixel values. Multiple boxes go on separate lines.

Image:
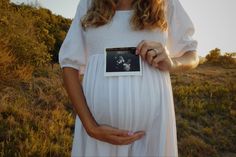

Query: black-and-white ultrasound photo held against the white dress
left=105, top=47, right=142, bottom=76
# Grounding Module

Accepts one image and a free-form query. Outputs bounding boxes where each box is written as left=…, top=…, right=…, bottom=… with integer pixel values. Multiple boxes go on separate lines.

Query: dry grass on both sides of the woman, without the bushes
left=0, top=62, right=236, bottom=157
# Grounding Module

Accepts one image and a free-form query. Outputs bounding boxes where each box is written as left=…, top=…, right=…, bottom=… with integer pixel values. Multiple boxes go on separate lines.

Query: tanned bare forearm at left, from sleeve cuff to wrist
left=63, top=67, right=97, bottom=133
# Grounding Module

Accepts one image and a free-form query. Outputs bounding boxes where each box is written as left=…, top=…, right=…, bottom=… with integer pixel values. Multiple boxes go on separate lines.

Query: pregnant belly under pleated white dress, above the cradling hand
left=83, top=55, right=169, bottom=131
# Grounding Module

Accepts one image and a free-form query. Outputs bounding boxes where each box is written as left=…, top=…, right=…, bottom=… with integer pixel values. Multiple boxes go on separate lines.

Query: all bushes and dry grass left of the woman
left=0, top=0, right=74, bottom=157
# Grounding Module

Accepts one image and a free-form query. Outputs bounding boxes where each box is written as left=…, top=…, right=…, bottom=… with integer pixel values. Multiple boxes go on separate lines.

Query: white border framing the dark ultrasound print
left=104, top=47, right=142, bottom=76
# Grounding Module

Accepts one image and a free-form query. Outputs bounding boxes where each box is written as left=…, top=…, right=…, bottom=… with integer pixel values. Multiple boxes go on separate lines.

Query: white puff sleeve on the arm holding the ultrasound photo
left=167, top=0, right=198, bottom=58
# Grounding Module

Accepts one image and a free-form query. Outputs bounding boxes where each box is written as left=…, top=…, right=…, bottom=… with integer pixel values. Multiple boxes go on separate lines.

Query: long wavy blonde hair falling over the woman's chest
left=81, top=0, right=167, bottom=31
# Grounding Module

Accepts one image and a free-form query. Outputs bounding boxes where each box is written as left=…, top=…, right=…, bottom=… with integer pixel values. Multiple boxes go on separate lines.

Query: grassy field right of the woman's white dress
left=172, top=64, right=236, bottom=157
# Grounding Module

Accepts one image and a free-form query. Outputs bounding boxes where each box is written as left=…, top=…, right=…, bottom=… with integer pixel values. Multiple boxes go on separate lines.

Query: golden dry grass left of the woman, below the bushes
left=0, top=65, right=74, bottom=157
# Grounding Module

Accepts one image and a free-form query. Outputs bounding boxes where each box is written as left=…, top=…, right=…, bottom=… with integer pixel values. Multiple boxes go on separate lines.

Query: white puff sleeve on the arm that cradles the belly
left=58, top=0, right=87, bottom=73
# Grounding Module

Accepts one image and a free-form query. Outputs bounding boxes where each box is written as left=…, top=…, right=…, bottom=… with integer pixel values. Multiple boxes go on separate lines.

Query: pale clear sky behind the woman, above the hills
left=12, top=0, right=236, bottom=56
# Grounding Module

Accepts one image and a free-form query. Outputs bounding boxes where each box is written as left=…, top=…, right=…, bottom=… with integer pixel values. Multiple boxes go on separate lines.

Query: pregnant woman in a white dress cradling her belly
left=59, top=0, right=198, bottom=157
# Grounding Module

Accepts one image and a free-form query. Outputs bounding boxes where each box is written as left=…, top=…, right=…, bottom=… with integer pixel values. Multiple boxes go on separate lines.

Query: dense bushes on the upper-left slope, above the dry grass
left=0, top=0, right=71, bottom=67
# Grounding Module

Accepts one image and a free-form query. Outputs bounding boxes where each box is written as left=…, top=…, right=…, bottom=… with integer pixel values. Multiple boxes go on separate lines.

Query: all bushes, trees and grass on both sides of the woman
left=0, top=0, right=236, bottom=157
